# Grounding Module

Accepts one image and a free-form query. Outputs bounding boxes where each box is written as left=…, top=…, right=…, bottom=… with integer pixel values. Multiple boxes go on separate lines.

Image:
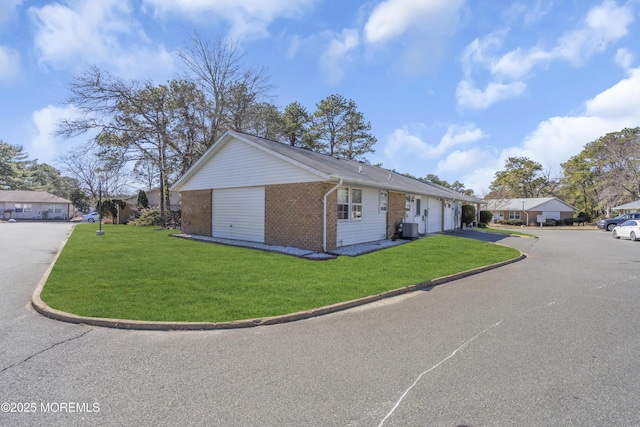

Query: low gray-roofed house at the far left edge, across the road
left=0, top=190, right=74, bottom=220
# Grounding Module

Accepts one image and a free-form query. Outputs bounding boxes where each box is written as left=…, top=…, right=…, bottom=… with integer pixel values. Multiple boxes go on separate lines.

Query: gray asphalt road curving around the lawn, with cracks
left=0, top=223, right=640, bottom=427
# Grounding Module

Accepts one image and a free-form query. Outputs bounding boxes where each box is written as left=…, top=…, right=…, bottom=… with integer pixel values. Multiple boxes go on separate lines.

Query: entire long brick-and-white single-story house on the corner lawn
left=171, top=131, right=482, bottom=252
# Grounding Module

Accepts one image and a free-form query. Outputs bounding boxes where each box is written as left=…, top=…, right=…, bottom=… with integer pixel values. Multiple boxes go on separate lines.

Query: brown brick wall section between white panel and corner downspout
left=264, top=182, right=337, bottom=251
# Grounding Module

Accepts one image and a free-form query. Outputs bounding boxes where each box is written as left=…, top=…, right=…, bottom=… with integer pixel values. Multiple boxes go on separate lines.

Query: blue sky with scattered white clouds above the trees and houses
left=0, top=0, right=640, bottom=195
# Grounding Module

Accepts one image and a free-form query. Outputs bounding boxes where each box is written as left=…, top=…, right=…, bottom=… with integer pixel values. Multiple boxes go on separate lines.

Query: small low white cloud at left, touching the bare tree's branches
left=25, top=105, right=77, bottom=164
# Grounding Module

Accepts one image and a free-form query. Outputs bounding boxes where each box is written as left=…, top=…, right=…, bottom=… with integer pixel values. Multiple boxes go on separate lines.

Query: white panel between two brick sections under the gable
left=212, top=187, right=264, bottom=243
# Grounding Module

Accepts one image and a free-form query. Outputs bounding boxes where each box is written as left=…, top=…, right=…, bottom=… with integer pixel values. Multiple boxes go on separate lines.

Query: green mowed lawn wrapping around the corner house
left=41, top=224, right=519, bottom=322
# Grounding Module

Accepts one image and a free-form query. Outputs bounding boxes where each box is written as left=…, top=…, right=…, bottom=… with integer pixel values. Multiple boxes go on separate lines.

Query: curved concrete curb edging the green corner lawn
left=31, top=240, right=526, bottom=331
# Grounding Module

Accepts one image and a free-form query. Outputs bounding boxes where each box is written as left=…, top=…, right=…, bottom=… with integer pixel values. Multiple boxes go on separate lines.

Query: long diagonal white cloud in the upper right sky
left=456, top=0, right=634, bottom=109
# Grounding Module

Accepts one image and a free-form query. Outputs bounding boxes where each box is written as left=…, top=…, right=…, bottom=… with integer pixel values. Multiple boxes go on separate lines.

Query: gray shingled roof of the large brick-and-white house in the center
left=176, top=131, right=482, bottom=203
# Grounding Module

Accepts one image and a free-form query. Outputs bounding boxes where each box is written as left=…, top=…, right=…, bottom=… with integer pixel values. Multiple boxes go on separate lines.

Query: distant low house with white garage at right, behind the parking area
left=486, top=197, right=576, bottom=225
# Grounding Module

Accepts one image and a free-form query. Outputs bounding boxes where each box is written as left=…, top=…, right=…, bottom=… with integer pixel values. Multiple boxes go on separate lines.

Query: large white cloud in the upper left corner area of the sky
left=29, top=0, right=173, bottom=79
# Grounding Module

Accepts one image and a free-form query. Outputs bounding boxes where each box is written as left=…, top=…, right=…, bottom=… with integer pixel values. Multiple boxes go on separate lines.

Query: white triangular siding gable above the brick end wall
left=180, top=139, right=320, bottom=191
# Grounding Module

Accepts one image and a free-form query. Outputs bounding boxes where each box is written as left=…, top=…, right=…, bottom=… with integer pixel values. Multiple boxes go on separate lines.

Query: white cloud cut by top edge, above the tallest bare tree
left=144, top=0, right=316, bottom=39
